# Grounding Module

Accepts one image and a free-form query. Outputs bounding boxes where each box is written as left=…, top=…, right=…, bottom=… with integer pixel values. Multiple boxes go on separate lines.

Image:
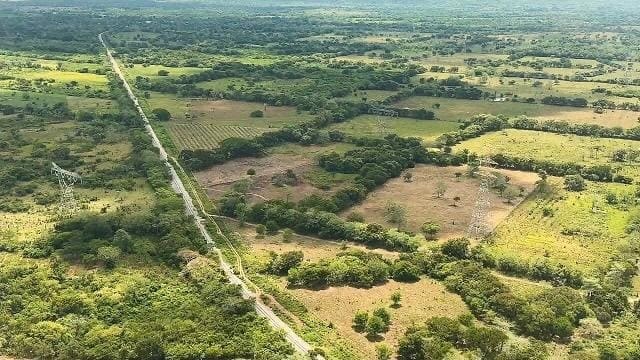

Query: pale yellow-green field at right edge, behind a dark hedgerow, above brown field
left=455, top=129, right=640, bottom=176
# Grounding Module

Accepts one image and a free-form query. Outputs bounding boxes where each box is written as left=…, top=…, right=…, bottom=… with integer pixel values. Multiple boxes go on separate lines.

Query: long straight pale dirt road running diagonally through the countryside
left=98, top=33, right=324, bottom=360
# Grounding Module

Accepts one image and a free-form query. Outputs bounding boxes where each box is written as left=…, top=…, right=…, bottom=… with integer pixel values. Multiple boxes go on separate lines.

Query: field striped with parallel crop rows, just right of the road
left=169, top=124, right=266, bottom=149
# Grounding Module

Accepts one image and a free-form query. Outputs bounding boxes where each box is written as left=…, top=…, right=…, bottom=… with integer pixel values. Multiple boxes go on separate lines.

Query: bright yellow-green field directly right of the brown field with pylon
left=489, top=179, right=634, bottom=274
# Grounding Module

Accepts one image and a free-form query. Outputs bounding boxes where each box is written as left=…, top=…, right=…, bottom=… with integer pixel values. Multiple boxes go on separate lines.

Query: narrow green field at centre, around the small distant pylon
left=331, top=115, right=459, bottom=141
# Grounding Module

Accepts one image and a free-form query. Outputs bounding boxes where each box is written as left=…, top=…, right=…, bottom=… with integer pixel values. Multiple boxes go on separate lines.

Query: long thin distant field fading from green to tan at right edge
left=394, top=96, right=639, bottom=128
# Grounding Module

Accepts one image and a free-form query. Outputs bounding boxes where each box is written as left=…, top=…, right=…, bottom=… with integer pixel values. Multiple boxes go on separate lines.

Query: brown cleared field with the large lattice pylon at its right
left=344, top=165, right=538, bottom=239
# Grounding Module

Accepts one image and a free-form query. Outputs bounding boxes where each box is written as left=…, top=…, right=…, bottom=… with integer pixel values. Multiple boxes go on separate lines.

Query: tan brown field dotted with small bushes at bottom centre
left=290, top=279, right=468, bottom=359
